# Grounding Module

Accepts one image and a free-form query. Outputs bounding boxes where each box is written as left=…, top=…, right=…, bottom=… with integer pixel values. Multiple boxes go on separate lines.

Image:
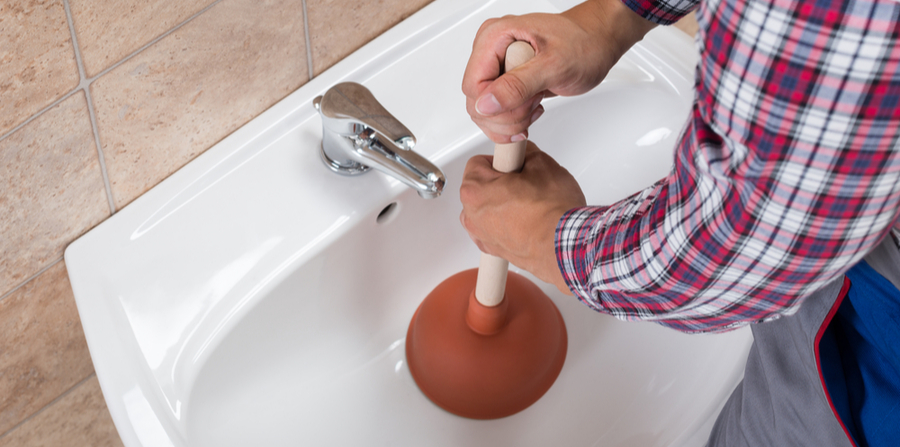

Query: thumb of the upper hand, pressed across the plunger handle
left=475, top=59, right=546, bottom=116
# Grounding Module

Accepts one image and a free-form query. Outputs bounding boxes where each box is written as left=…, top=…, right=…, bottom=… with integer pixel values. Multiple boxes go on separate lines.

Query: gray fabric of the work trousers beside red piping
left=707, top=237, right=900, bottom=447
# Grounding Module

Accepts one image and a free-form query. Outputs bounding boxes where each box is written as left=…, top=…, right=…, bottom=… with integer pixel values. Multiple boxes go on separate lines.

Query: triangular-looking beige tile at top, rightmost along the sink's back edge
left=306, top=0, right=432, bottom=75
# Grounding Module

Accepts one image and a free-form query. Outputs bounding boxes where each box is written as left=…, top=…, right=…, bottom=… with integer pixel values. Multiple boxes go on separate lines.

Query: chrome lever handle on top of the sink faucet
left=316, top=82, right=416, bottom=150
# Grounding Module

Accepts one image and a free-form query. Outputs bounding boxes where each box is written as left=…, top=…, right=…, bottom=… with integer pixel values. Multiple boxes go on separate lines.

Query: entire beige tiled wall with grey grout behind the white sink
left=0, top=0, right=431, bottom=447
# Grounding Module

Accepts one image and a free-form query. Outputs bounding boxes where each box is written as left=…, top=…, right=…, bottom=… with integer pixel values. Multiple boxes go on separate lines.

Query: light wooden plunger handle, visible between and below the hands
left=475, top=41, right=534, bottom=307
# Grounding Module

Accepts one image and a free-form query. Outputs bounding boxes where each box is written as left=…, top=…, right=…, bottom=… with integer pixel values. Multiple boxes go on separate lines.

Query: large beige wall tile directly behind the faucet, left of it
left=91, top=0, right=309, bottom=207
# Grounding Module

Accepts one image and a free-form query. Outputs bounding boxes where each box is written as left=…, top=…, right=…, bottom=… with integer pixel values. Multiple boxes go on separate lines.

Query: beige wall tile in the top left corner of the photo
left=0, top=0, right=79, bottom=135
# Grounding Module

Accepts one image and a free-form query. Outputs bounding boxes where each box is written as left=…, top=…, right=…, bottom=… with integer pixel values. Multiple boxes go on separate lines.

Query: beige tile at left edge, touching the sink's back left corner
left=0, top=92, right=109, bottom=296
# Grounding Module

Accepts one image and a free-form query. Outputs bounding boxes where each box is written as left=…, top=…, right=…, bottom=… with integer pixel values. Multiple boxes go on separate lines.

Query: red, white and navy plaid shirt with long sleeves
left=556, top=0, right=900, bottom=332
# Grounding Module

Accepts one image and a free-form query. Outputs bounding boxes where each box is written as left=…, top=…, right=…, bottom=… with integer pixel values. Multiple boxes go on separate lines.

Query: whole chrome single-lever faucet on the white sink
left=313, top=82, right=444, bottom=199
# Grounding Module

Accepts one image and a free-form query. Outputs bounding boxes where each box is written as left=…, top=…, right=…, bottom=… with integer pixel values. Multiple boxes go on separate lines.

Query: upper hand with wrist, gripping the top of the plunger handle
left=462, top=0, right=654, bottom=143
